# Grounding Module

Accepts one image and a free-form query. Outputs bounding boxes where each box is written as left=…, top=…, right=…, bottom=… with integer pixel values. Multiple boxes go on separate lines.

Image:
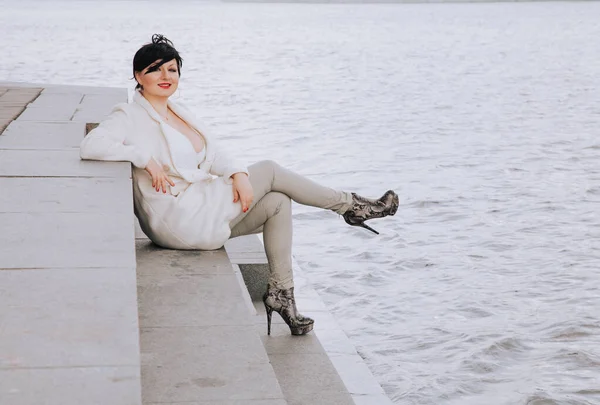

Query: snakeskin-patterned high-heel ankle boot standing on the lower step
left=263, top=286, right=315, bottom=335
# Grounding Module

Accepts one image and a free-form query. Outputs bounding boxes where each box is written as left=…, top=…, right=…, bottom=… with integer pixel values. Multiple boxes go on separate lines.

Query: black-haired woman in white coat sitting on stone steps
left=81, top=35, right=398, bottom=335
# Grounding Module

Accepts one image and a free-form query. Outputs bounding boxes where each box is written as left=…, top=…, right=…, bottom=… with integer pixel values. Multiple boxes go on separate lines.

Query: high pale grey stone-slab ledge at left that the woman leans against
left=0, top=84, right=141, bottom=405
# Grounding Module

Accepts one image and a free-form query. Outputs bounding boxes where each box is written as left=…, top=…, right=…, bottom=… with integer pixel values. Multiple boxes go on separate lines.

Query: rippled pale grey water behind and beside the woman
left=0, top=0, right=600, bottom=405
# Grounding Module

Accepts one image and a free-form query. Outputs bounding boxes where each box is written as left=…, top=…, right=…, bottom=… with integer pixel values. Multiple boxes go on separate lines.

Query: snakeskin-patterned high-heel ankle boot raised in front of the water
left=342, top=190, right=399, bottom=235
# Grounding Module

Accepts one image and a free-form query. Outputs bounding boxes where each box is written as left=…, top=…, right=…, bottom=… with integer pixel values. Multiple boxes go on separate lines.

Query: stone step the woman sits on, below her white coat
left=136, top=239, right=286, bottom=405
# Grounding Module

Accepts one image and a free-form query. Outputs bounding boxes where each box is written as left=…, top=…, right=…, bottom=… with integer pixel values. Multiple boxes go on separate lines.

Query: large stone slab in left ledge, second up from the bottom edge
left=0, top=268, right=139, bottom=368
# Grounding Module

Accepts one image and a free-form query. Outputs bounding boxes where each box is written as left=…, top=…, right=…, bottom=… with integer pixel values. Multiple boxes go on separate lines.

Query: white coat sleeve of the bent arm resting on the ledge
left=79, top=106, right=152, bottom=169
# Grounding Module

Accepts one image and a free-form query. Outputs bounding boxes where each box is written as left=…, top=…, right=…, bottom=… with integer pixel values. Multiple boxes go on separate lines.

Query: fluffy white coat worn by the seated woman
left=80, top=91, right=248, bottom=250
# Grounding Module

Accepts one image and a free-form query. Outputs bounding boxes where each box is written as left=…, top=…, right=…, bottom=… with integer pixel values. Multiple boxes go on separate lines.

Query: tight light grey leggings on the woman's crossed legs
left=230, top=160, right=352, bottom=289
